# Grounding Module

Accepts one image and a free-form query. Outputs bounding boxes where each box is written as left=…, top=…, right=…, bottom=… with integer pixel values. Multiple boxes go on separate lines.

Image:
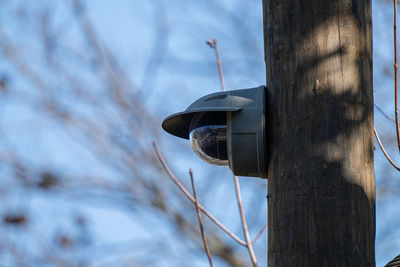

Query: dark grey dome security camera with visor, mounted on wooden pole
left=162, top=86, right=267, bottom=178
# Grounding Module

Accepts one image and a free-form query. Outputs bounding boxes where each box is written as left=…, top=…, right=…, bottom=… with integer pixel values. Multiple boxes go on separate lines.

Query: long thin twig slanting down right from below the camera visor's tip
left=153, top=142, right=246, bottom=246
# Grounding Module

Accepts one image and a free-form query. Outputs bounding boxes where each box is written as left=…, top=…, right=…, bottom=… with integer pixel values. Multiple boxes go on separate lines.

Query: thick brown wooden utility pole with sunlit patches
left=263, top=0, right=375, bottom=267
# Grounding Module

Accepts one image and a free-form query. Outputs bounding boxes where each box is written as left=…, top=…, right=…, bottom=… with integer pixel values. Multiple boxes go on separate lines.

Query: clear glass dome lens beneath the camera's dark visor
left=189, top=125, right=228, bottom=165
